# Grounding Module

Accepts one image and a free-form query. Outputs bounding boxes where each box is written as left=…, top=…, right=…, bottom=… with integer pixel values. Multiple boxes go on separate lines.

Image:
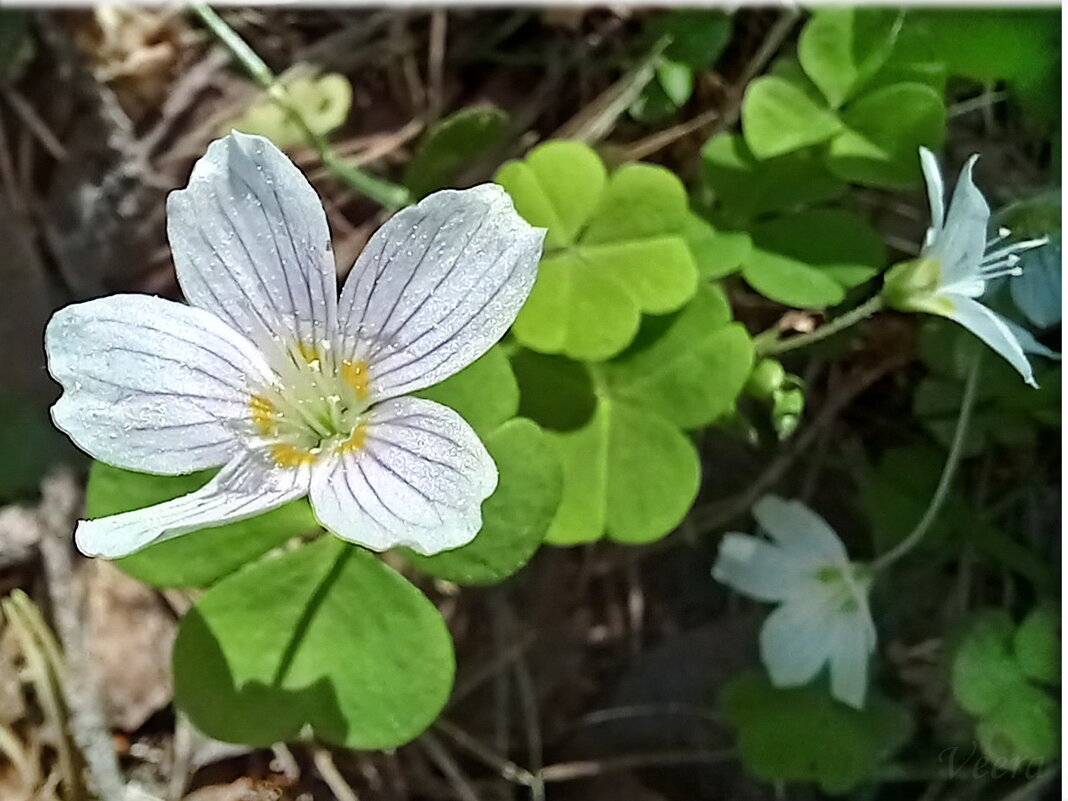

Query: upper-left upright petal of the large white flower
left=167, top=131, right=337, bottom=352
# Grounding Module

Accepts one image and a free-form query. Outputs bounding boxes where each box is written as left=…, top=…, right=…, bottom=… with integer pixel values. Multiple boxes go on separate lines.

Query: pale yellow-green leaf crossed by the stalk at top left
left=228, top=69, right=352, bottom=150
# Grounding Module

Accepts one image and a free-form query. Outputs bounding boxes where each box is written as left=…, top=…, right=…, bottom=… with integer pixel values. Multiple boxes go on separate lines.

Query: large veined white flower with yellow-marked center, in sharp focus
left=45, top=132, right=545, bottom=557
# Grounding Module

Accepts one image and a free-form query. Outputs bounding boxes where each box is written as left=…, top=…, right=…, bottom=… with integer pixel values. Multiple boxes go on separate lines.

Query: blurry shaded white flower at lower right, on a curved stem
left=712, top=496, right=876, bottom=708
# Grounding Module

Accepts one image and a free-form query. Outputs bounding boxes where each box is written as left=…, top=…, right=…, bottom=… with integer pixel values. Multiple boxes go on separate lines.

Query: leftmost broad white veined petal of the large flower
left=45, top=295, right=267, bottom=474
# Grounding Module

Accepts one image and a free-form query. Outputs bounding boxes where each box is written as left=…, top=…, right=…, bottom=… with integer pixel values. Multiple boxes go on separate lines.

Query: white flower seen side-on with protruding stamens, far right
left=883, top=147, right=1056, bottom=387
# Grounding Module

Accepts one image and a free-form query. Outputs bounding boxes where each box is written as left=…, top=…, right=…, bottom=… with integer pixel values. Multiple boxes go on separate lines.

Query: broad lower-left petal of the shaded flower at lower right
left=760, top=594, right=832, bottom=687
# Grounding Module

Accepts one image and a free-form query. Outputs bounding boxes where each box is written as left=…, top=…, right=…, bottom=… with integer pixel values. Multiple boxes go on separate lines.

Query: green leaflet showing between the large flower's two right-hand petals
left=414, top=345, right=519, bottom=436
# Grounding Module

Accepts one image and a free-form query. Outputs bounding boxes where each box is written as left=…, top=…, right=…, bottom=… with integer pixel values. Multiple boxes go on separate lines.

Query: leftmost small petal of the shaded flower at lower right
left=712, top=534, right=812, bottom=601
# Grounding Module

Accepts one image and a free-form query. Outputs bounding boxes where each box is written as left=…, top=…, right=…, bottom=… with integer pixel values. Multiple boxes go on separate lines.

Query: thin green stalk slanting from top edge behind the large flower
left=190, top=4, right=412, bottom=210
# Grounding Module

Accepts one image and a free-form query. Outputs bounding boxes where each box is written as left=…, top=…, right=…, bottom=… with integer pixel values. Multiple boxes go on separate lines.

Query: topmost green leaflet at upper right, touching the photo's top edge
left=798, top=6, right=905, bottom=108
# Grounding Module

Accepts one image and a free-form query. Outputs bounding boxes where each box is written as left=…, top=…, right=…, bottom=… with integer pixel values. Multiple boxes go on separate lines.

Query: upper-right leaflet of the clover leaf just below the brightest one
left=595, top=285, right=753, bottom=428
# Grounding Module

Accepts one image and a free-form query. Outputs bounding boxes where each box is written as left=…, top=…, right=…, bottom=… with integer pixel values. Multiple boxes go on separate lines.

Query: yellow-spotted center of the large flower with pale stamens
left=249, top=340, right=370, bottom=467
